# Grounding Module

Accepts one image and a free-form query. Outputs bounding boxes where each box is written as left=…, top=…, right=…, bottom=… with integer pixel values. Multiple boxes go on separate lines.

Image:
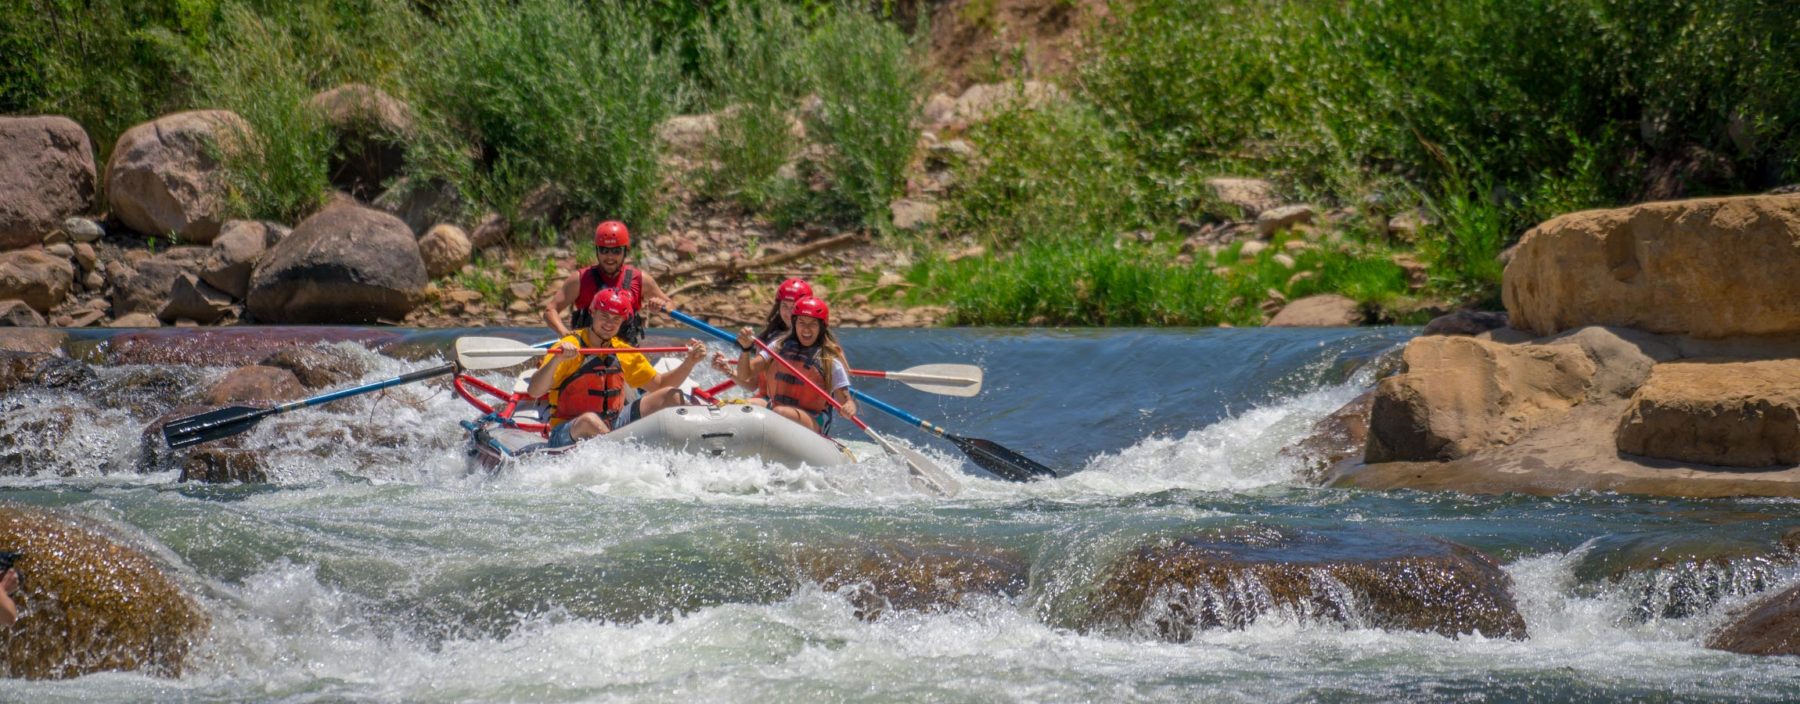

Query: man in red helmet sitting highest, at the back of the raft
left=544, top=220, right=675, bottom=344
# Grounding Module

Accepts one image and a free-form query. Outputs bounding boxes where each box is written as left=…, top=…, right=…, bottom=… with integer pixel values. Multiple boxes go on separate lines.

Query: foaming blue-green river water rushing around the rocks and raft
left=0, top=328, right=1800, bottom=704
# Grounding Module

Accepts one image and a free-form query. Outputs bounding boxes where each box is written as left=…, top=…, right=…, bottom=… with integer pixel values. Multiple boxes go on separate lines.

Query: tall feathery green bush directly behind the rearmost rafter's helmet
left=410, top=0, right=682, bottom=223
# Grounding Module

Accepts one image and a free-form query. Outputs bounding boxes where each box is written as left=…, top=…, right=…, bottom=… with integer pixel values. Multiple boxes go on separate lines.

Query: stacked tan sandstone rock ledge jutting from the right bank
left=1327, top=196, right=1800, bottom=497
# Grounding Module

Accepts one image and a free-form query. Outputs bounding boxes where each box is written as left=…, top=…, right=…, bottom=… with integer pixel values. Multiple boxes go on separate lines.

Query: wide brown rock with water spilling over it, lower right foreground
left=1080, top=526, right=1525, bottom=643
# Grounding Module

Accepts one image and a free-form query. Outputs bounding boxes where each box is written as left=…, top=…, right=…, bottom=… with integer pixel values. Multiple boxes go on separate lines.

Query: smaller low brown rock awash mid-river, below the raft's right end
left=794, top=540, right=1030, bottom=619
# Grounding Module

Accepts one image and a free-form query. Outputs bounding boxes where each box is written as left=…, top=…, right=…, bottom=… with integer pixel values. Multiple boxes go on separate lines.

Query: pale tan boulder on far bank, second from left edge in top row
left=106, top=110, right=250, bottom=245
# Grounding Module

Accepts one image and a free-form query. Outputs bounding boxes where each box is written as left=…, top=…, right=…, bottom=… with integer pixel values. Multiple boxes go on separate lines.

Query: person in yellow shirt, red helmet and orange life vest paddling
left=526, top=288, right=706, bottom=448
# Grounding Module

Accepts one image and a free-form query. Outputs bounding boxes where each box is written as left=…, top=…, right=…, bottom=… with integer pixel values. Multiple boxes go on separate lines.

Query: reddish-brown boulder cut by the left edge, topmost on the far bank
left=0, top=115, right=94, bottom=250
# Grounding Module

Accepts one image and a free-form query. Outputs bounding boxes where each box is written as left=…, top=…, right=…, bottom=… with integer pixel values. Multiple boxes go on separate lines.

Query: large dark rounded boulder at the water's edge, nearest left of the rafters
left=248, top=205, right=428, bottom=324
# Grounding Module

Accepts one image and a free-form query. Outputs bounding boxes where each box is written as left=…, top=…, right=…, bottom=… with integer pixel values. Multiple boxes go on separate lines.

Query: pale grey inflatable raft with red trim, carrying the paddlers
left=454, top=375, right=855, bottom=472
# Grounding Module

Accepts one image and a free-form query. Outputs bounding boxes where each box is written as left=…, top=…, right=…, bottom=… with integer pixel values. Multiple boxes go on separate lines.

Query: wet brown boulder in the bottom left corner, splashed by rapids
left=0, top=506, right=207, bottom=679
